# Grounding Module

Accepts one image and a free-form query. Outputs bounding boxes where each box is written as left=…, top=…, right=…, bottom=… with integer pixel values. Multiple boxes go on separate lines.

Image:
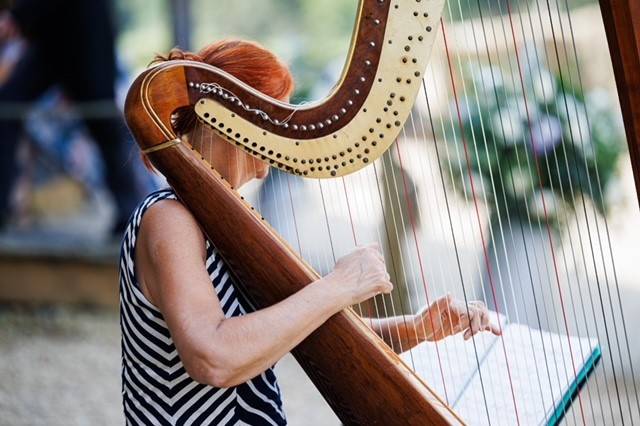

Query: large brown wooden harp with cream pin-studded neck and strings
left=126, top=0, right=640, bottom=425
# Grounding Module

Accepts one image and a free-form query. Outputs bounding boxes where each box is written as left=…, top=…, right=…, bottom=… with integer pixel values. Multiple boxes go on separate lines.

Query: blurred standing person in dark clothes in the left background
left=0, top=0, right=148, bottom=235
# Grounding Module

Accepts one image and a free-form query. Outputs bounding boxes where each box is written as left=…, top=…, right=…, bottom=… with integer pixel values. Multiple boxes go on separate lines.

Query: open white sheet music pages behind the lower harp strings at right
left=403, top=324, right=598, bottom=425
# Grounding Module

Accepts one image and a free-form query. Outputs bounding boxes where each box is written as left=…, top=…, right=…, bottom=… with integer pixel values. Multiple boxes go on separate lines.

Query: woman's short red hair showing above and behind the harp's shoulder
left=143, top=40, right=294, bottom=169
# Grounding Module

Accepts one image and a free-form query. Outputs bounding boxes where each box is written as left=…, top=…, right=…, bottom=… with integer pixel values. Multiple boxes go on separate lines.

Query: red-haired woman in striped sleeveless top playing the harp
left=120, top=41, right=499, bottom=425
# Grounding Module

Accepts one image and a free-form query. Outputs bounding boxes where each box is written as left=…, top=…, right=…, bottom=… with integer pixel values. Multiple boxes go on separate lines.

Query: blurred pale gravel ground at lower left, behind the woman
left=0, top=308, right=339, bottom=426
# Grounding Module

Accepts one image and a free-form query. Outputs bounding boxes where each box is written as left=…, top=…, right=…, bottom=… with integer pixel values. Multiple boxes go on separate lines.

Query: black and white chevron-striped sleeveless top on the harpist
left=120, top=190, right=286, bottom=425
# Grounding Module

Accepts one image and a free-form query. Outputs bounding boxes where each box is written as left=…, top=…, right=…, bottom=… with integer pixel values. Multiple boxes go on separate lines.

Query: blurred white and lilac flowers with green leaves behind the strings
left=445, top=58, right=625, bottom=226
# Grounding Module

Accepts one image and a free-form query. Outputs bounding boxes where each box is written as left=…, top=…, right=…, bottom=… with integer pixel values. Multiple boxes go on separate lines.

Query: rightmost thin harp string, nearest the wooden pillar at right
left=556, top=0, right=640, bottom=422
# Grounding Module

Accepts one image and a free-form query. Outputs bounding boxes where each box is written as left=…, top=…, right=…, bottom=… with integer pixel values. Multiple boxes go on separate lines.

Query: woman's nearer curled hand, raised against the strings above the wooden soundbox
left=322, top=244, right=393, bottom=308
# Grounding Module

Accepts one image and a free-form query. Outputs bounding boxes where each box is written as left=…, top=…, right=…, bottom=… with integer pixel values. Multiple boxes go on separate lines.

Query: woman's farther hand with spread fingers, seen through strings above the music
left=413, top=295, right=501, bottom=341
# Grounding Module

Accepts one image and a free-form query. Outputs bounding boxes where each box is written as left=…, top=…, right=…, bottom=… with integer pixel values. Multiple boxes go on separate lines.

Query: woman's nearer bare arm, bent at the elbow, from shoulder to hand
left=136, top=200, right=391, bottom=387
